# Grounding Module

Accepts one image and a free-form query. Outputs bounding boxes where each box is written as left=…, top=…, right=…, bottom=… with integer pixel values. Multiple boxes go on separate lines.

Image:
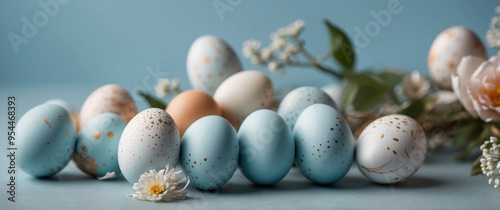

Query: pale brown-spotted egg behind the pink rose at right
left=428, top=26, right=487, bottom=90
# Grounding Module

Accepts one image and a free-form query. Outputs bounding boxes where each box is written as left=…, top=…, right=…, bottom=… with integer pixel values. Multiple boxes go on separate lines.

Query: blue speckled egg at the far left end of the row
left=16, top=104, right=76, bottom=177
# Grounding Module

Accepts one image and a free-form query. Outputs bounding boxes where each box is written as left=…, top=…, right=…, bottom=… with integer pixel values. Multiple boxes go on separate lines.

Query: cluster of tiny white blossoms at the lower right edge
left=480, top=136, right=500, bottom=188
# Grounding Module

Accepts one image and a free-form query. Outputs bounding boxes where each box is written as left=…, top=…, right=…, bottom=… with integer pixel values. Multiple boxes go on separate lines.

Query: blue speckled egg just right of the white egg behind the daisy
left=180, top=115, right=239, bottom=190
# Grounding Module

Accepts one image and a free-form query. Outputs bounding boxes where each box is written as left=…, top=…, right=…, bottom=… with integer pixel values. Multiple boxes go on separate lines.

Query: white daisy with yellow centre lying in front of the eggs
left=129, top=165, right=190, bottom=202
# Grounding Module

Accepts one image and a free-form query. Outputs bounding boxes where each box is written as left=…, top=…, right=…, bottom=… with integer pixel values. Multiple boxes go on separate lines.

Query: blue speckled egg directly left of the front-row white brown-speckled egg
left=293, top=104, right=354, bottom=184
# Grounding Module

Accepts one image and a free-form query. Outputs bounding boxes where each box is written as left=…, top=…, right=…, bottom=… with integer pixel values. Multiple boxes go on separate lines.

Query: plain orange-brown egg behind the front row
left=167, top=90, right=221, bottom=137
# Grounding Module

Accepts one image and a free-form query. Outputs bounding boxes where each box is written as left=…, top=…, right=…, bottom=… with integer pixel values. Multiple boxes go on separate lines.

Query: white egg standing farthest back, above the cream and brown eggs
left=186, top=35, right=241, bottom=95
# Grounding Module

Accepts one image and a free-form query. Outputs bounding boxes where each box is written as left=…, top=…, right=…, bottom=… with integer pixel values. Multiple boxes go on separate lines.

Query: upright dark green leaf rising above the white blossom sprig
left=325, top=20, right=356, bottom=72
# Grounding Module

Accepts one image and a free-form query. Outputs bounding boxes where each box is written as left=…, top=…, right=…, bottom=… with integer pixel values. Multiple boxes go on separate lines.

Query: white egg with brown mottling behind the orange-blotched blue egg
left=80, top=84, right=137, bottom=126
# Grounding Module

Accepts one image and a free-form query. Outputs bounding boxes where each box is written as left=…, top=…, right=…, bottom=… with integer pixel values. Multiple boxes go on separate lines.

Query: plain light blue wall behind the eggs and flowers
left=0, top=0, right=498, bottom=92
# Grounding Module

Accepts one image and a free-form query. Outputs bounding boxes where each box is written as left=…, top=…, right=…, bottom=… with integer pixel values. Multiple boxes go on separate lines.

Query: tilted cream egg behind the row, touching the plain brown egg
left=214, top=71, right=274, bottom=129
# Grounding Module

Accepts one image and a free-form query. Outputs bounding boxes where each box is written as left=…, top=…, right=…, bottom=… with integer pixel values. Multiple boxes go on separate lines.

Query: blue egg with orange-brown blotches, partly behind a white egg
left=73, top=113, right=127, bottom=176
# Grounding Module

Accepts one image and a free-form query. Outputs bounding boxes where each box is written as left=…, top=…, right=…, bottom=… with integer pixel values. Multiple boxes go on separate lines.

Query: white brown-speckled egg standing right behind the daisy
left=118, top=108, right=180, bottom=183
